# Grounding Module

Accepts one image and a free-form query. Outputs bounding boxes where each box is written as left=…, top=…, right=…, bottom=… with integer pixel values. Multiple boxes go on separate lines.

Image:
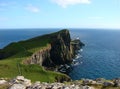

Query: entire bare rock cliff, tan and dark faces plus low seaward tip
left=25, top=30, right=84, bottom=66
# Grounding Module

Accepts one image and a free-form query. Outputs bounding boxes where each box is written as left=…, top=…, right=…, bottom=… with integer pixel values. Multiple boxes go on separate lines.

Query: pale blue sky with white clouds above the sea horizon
left=0, top=0, right=120, bottom=29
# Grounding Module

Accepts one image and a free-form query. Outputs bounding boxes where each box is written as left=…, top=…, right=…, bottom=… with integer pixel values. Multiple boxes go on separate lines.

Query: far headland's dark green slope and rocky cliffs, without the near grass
left=0, top=29, right=84, bottom=66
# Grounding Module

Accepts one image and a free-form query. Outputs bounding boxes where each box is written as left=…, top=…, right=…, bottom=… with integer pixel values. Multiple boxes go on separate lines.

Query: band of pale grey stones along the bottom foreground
left=0, top=76, right=120, bottom=89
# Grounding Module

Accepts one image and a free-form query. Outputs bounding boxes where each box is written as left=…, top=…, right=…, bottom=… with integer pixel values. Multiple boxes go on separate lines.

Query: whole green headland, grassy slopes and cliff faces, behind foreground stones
left=0, top=30, right=83, bottom=82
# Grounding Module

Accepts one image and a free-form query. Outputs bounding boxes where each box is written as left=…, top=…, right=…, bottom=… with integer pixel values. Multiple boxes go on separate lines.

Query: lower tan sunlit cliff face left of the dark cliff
left=24, top=45, right=52, bottom=66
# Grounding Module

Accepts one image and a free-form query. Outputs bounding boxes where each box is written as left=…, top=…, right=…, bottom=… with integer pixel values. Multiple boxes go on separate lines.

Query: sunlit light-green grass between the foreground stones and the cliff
left=0, top=58, right=66, bottom=82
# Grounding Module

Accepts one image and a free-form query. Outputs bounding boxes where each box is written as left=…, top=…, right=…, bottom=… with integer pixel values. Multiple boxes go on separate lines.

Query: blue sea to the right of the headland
left=69, top=29, right=120, bottom=80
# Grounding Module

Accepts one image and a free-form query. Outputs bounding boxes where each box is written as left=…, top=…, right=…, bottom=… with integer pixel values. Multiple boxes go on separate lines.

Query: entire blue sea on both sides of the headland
left=0, top=28, right=120, bottom=80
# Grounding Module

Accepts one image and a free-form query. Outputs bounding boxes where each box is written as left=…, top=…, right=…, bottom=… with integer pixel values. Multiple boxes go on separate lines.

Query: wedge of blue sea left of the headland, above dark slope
left=0, top=29, right=60, bottom=48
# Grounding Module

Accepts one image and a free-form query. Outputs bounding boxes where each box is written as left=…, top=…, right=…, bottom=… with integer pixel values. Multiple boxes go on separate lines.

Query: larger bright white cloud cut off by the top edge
left=52, top=0, right=91, bottom=8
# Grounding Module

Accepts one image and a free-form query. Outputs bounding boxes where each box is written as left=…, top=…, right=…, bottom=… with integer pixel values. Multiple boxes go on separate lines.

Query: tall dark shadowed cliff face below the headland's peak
left=50, top=30, right=72, bottom=65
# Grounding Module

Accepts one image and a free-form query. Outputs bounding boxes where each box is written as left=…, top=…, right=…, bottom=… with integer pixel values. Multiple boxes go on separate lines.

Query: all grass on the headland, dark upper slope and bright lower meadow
left=0, top=30, right=69, bottom=82
